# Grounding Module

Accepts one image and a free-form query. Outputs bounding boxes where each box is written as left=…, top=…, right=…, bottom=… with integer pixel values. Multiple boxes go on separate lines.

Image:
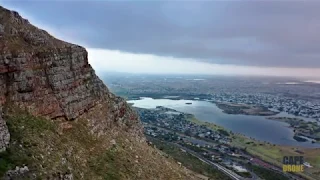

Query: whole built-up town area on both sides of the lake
left=103, top=74, right=320, bottom=180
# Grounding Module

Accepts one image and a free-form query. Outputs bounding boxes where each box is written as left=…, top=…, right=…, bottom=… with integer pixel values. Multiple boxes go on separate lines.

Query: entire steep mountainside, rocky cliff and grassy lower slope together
left=0, top=6, right=193, bottom=179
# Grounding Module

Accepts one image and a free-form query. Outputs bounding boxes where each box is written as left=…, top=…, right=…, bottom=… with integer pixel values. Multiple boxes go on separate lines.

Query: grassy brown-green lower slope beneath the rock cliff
left=0, top=110, right=198, bottom=180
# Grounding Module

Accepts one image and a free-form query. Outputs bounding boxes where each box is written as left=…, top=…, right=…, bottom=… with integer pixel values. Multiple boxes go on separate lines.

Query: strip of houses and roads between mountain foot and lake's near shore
left=134, top=106, right=294, bottom=179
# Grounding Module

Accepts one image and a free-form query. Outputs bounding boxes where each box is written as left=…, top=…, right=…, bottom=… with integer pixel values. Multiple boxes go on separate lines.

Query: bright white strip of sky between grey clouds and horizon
left=87, top=48, right=320, bottom=79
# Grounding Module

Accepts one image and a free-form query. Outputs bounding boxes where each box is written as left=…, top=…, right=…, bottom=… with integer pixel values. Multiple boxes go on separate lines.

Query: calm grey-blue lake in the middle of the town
left=128, top=98, right=320, bottom=147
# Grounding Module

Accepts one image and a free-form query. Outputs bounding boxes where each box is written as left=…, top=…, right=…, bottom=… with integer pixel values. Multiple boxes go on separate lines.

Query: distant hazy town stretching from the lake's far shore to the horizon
left=104, top=74, right=320, bottom=121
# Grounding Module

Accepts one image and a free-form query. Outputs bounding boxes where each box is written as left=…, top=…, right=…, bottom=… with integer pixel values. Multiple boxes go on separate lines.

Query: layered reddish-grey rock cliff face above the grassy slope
left=0, top=7, right=141, bottom=148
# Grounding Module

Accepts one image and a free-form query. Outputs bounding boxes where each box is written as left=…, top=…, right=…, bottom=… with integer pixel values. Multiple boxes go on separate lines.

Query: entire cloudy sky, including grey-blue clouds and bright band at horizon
left=0, top=0, right=320, bottom=77
